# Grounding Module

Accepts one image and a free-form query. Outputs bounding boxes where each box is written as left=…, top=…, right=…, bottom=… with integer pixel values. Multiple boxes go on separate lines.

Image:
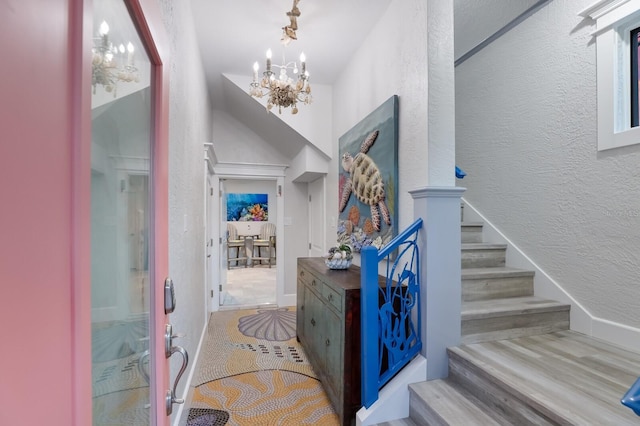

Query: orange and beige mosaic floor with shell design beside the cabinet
left=192, top=308, right=339, bottom=426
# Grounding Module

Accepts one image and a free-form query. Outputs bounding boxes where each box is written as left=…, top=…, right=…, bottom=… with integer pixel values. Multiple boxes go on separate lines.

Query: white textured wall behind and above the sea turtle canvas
left=327, top=0, right=430, bottom=253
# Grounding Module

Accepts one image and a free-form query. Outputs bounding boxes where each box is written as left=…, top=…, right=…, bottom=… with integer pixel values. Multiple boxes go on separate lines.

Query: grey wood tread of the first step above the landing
left=462, top=296, right=571, bottom=320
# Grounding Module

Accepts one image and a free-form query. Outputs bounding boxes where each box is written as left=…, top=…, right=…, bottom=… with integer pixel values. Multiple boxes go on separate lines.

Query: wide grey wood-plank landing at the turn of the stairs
left=448, top=331, right=640, bottom=425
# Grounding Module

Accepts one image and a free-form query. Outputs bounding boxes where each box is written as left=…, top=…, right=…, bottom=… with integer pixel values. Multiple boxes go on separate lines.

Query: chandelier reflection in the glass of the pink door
left=91, top=21, right=139, bottom=98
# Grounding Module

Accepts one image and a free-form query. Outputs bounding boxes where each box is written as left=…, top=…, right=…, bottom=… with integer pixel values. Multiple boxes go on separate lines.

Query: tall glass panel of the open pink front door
left=91, top=0, right=152, bottom=425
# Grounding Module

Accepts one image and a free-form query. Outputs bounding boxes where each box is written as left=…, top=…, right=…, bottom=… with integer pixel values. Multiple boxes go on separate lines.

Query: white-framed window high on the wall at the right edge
left=579, top=0, right=640, bottom=151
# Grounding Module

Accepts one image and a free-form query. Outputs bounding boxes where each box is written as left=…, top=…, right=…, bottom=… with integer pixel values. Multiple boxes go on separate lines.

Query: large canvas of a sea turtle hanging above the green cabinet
left=338, top=95, right=398, bottom=252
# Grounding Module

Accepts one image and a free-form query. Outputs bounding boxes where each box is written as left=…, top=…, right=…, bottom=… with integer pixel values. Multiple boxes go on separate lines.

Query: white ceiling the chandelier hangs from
left=191, top=0, right=391, bottom=109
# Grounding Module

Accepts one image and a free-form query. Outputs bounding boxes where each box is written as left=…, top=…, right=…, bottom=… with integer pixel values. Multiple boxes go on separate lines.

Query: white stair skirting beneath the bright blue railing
left=356, top=355, right=427, bottom=426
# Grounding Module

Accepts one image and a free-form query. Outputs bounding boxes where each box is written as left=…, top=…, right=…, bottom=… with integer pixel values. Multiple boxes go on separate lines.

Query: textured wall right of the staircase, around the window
left=456, top=0, right=640, bottom=327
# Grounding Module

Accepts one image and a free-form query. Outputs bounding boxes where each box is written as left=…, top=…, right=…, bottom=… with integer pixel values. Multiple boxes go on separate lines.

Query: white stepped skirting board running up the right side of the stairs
left=462, top=197, right=640, bottom=351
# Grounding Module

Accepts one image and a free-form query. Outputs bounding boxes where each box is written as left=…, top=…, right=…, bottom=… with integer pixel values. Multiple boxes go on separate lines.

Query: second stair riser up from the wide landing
left=462, top=276, right=533, bottom=302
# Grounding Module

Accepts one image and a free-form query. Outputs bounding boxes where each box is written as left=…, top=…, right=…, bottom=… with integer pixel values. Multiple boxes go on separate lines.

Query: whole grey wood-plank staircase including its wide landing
left=380, top=223, right=640, bottom=426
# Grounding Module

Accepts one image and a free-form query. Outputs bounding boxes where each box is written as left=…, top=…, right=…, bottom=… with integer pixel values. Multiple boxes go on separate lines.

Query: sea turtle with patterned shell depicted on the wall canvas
left=340, top=130, right=391, bottom=231
